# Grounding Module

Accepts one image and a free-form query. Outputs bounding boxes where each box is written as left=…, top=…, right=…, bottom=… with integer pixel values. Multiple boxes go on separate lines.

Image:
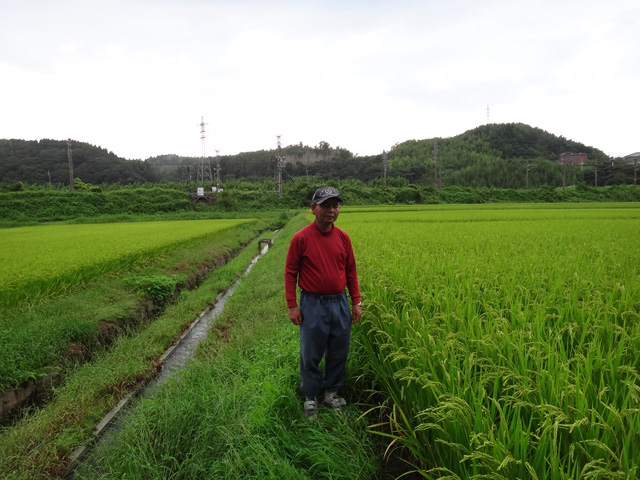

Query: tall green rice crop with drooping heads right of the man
left=340, top=206, right=640, bottom=479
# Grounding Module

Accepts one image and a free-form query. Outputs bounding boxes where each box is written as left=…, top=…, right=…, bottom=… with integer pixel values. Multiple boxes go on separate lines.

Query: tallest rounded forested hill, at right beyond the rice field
left=388, top=123, right=633, bottom=188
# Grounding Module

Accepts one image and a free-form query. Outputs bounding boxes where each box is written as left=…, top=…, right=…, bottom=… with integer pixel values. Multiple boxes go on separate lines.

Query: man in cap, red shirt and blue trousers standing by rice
left=285, top=187, right=362, bottom=419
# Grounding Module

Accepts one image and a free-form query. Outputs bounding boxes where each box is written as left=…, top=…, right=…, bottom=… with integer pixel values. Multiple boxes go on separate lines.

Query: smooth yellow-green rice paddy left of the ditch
left=0, top=219, right=255, bottom=306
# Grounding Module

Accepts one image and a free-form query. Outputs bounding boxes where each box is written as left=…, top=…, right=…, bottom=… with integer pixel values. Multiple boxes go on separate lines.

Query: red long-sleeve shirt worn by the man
left=284, top=222, right=360, bottom=308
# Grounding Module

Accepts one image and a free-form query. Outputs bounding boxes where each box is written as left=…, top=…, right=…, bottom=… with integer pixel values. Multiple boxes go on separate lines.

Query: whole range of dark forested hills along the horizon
left=0, top=123, right=634, bottom=188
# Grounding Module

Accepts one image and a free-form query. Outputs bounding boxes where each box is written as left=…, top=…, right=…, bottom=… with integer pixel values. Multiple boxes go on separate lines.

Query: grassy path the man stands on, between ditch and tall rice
left=74, top=215, right=378, bottom=480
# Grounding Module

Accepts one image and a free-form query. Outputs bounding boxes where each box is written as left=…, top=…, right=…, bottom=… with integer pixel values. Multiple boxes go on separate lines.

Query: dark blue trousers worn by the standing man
left=300, top=290, right=351, bottom=398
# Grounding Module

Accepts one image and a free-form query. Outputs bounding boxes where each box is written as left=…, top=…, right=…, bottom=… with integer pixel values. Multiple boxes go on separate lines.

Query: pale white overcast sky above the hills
left=0, top=0, right=640, bottom=159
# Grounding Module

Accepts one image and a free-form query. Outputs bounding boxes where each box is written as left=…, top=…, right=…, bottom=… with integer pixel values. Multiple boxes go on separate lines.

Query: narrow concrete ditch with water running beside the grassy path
left=64, top=230, right=279, bottom=479
